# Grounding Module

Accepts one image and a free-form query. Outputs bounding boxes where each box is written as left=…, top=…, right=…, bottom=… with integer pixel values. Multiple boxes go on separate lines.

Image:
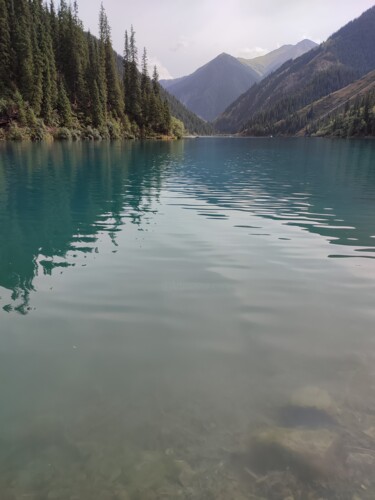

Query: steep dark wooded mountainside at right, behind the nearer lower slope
left=215, top=6, right=375, bottom=135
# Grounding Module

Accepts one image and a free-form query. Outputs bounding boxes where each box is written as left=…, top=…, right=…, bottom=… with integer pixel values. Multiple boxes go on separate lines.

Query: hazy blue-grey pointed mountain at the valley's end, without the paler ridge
left=160, top=53, right=260, bottom=121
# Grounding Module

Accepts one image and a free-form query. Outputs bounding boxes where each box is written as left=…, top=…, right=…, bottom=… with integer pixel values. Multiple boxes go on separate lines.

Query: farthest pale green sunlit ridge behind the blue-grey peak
left=238, top=39, right=318, bottom=78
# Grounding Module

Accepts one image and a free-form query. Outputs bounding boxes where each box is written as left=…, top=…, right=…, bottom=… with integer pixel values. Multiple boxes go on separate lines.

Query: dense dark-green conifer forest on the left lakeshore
left=0, top=0, right=209, bottom=140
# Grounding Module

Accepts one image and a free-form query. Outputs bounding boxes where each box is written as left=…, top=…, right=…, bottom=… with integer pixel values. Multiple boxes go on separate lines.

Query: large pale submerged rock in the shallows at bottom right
left=250, top=427, right=339, bottom=480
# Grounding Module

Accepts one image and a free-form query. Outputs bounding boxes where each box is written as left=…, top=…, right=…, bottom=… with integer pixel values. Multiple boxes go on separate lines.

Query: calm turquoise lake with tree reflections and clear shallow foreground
left=0, top=138, right=375, bottom=500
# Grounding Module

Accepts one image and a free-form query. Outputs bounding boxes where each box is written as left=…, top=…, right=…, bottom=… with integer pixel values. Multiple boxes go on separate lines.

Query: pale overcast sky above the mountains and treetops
left=71, top=0, right=375, bottom=78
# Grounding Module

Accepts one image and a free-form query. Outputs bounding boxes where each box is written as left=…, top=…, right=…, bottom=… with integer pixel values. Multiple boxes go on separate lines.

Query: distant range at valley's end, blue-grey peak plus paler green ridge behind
left=160, top=40, right=317, bottom=121
